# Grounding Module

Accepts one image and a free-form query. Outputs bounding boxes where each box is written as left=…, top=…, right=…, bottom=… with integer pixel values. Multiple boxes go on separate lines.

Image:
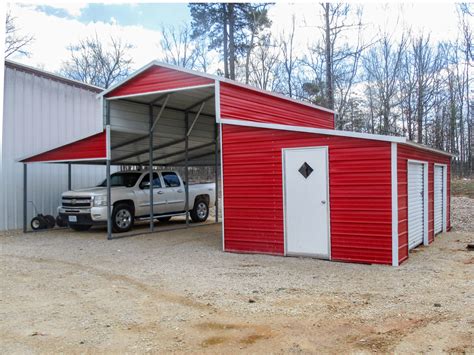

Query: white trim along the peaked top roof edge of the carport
left=97, top=60, right=336, bottom=114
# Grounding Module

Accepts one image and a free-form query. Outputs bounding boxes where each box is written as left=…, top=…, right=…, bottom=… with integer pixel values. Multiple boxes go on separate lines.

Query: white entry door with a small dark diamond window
left=283, top=147, right=329, bottom=259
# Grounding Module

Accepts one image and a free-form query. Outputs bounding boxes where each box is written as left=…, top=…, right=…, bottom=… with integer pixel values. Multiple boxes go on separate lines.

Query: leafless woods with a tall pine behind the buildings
left=7, top=3, right=474, bottom=176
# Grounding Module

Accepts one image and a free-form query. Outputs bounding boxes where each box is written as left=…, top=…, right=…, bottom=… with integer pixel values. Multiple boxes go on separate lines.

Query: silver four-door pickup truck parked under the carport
left=58, top=171, right=216, bottom=233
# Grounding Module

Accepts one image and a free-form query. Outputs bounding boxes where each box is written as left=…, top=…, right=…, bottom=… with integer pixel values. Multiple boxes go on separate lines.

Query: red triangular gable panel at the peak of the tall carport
left=106, top=66, right=214, bottom=97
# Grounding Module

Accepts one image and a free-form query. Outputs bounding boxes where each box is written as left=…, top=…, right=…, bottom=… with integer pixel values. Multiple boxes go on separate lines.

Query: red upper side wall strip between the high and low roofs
left=220, top=83, right=334, bottom=129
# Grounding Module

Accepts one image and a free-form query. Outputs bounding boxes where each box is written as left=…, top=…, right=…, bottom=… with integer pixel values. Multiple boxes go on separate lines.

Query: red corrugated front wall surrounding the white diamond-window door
left=222, top=125, right=392, bottom=264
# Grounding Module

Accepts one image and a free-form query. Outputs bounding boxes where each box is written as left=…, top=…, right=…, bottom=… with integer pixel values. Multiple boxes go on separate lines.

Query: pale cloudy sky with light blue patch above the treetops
left=7, top=2, right=457, bottom=72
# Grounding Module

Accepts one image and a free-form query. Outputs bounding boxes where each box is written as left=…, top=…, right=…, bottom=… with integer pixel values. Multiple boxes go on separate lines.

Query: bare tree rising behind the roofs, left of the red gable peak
left=60, top=34, right=133, bottom=88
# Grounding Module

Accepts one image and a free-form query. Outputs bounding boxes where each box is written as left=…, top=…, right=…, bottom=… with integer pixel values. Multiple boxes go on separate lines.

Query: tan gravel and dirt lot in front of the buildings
left=0, top=199, right=474, bottom=354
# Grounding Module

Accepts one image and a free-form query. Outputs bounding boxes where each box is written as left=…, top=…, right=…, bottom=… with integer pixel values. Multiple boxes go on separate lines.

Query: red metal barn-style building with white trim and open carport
left=21, top=62, right=451, bottom=265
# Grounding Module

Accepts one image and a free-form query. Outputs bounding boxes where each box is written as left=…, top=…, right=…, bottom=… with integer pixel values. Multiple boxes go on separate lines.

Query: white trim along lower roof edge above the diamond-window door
left=221, top=118, right=406, bottom=143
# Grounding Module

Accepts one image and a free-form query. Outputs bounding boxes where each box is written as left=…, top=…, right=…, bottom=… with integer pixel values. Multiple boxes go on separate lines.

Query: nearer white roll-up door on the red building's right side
left=408, top=162, right=425, bottom=249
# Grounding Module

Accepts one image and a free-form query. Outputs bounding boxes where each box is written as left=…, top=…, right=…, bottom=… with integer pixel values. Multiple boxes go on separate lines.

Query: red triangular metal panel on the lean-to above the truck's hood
left=23, top=131, right=107, bottom=163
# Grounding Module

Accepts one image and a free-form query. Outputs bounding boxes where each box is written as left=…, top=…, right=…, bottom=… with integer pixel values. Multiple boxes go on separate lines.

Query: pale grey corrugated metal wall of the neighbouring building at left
left=0, top=67, right=105, bottom=230
